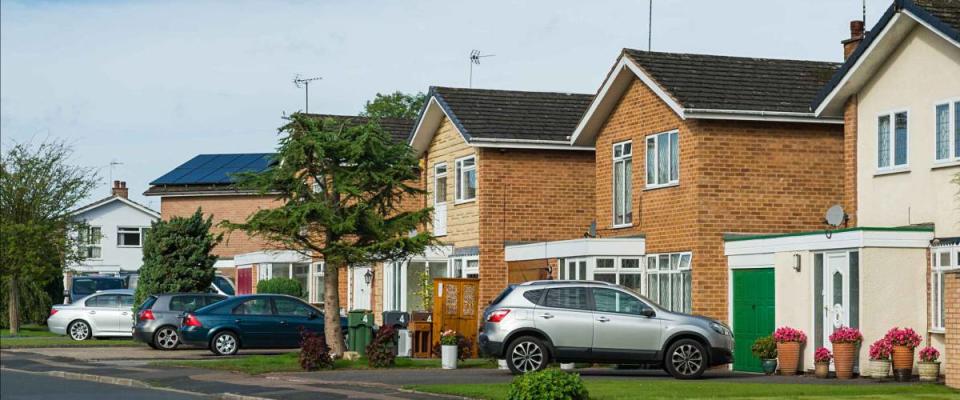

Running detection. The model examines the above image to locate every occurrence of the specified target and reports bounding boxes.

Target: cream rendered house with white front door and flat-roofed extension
[726,0,960,371]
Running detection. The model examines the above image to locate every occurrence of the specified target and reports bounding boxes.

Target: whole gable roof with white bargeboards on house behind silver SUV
[572,49,842,144]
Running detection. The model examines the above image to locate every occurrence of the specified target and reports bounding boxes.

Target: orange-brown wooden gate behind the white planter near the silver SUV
[433,278,480,357]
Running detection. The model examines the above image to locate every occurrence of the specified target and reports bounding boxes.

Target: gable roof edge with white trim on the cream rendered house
[812,0,960,116]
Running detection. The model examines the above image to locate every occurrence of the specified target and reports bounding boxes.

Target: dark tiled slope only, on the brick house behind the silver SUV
[623,49,840,113]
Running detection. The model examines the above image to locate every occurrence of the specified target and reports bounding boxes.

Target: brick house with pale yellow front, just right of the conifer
[383,87,594,311]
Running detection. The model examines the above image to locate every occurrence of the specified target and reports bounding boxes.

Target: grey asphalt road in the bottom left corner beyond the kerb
[0,370,202,400]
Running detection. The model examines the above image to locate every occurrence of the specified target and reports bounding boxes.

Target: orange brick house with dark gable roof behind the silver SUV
[506,49,843,370]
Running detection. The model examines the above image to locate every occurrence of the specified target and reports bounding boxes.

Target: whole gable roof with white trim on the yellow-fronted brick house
[408,86,593,154]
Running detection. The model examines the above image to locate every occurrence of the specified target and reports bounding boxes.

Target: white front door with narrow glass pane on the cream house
[823,252,850,350]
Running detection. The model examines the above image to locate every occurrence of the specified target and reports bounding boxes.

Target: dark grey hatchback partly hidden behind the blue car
[133,293,227,350]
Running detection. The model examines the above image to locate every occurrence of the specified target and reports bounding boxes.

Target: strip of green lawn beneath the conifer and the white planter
[153,352,497,375]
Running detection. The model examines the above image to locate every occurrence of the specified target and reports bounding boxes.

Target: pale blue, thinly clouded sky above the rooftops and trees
[0,0,892,209]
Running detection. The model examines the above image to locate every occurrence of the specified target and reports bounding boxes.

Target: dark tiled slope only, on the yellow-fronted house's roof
[430,87,593,141]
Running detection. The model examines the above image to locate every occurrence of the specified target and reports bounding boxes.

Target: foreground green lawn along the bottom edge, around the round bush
[405,378,960,400]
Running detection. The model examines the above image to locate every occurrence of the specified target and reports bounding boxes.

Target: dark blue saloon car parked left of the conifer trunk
[180,294,347,356]
